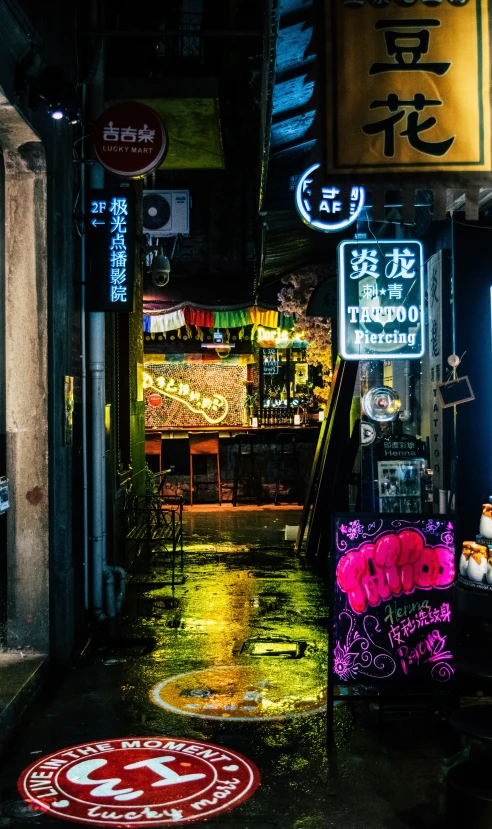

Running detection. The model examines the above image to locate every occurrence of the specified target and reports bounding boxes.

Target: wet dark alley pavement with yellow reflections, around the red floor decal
[0,508,456,829]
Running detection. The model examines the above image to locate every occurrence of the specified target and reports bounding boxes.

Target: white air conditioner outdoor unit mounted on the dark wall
[143,190,190,238]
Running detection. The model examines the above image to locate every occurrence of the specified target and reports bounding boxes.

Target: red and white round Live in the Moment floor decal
[18,737,260,827]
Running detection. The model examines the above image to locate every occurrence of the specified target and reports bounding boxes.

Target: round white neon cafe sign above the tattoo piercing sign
[295,164,365,233]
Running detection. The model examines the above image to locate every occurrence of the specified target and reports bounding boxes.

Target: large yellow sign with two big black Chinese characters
[326,0,491,173]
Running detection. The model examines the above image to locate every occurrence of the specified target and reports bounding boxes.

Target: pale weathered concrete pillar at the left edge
[0,115,49,651]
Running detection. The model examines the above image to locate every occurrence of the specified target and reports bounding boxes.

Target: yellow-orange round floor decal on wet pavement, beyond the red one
[150,662,326,721]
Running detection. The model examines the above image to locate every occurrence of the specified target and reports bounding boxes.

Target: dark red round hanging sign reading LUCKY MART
[92,101,168,178]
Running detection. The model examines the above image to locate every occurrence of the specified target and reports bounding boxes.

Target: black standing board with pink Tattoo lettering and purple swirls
[329,513,455,691]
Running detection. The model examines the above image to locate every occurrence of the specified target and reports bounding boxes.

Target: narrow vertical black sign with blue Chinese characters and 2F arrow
[86,188,135,312]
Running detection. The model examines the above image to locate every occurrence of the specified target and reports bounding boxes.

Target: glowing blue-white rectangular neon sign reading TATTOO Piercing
[338,240,424,360]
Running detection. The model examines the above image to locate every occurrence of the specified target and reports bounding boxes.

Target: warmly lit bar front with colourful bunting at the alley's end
[142,303,321,502]
